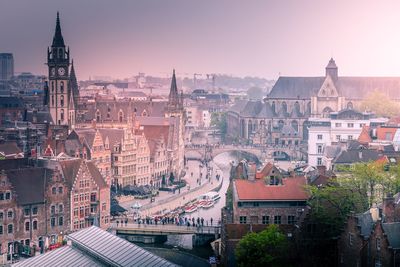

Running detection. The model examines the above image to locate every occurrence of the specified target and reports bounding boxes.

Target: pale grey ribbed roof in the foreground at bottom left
[68,226,176,267]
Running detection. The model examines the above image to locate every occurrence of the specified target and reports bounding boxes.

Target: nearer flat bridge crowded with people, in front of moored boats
[110,223,221,235]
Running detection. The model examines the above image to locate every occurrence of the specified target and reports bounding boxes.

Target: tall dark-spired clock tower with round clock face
[47,12,75,129]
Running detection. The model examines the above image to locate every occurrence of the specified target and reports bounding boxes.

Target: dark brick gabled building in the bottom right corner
[338,195,400,266]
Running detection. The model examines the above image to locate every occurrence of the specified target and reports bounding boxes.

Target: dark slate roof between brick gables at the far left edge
[6,168,51,205]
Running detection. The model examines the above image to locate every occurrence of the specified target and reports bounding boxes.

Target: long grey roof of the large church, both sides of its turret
[268,77,400,99]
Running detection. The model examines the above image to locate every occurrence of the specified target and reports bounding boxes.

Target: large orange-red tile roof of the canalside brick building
[234,176,308,201]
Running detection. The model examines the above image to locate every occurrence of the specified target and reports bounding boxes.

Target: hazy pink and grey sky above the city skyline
[0,0,400,79]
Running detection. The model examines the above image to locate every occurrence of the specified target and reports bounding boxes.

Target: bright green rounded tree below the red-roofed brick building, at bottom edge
[235,224,288,267]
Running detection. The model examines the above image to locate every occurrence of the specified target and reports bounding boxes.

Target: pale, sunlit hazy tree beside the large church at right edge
[360,90,400,117]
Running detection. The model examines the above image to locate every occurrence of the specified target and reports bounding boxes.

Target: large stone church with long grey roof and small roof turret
[227,58,400,148]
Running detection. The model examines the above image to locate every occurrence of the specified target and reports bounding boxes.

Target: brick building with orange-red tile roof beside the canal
[221,161,308,266]
